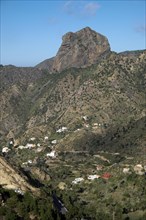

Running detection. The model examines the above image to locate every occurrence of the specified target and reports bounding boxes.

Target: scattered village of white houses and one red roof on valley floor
[1,120,146,193]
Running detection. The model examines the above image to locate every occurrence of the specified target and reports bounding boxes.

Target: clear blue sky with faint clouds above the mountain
[0,0,146,66]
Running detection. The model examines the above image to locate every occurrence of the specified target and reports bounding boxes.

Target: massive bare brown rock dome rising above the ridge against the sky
[36,27,110,72]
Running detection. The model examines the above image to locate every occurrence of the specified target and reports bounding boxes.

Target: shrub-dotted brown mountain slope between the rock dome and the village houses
[1,51,146,147]
